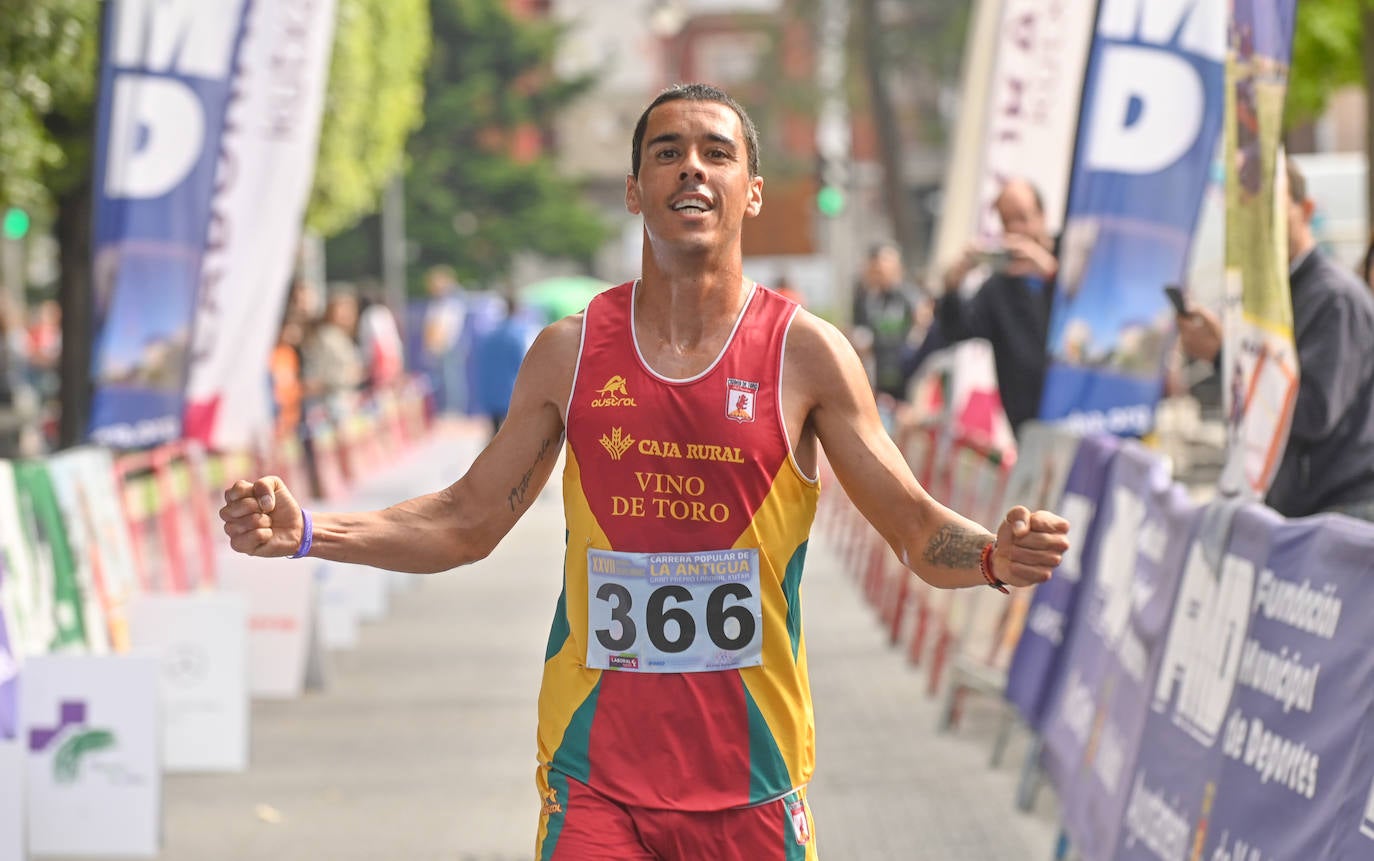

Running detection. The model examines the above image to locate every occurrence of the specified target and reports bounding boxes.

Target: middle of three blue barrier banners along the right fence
[1043,444,1198,860]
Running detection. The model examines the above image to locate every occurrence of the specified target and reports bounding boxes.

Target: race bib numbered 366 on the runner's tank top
[587,549,764,673]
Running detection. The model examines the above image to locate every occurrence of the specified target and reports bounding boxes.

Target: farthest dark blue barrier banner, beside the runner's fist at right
[1006,434,1120,732]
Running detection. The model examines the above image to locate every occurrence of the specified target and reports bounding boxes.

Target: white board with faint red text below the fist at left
[217,551,315,699]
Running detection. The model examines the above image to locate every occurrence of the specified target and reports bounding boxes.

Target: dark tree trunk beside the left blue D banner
[56,181,95,448]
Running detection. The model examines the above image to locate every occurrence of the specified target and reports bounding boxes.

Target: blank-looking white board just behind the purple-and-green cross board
[129,593,249,773]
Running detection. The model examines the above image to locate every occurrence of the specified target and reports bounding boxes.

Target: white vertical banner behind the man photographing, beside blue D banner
[972,0,1098,245]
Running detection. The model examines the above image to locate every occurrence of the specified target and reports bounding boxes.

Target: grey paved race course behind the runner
[80,425,1055,861]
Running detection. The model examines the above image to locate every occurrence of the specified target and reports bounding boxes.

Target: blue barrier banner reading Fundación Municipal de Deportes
[1114,505,1374,861]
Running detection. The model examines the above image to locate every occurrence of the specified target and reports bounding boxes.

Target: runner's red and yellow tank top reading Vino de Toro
[539,283,819,810]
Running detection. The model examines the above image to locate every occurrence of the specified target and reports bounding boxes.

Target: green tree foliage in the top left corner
[0,0,100,209]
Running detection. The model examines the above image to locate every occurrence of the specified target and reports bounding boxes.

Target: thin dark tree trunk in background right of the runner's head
[855,0,921,266]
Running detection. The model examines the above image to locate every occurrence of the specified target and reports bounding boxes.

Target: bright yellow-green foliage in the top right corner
[1285,0,1374,126]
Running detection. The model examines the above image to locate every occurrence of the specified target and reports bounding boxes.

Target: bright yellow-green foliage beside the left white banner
[306,0,430,236]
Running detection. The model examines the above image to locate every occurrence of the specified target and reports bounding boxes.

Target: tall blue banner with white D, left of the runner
[89,0,250,448]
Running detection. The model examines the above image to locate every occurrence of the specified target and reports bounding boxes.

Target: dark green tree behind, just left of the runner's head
[405,0,620,284]
